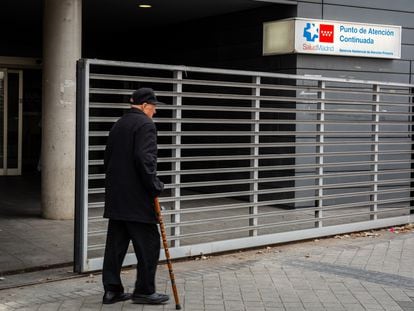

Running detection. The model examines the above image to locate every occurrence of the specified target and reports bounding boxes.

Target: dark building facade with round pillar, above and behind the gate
[0,0,414,219]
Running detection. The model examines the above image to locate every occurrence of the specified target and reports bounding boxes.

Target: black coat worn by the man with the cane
[104,108,164,223]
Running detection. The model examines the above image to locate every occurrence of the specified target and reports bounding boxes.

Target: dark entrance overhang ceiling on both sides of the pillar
[0,0,297,27]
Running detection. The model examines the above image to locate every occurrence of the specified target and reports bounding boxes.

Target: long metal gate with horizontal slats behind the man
[75,59,414,272]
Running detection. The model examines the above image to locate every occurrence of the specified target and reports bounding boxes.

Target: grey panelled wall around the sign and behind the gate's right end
[296,0,414,210]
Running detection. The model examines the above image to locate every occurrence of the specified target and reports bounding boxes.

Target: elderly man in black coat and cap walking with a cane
[102,88,169,304]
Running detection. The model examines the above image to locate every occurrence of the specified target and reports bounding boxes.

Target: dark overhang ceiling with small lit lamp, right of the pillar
[83,0,297,28]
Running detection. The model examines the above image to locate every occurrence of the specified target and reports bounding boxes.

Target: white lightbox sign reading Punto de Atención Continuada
[263,18,401,59]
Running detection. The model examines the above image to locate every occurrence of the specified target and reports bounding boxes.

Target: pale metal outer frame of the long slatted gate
[74,59,414,273]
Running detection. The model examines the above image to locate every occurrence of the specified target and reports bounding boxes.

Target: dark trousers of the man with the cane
[102,219,161,295]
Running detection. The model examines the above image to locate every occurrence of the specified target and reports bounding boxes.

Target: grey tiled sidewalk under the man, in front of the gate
[0,230,414,311]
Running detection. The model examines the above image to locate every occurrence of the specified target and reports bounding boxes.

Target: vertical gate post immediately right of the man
[171,71,183,247]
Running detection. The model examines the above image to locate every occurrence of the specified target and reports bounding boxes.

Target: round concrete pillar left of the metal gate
[42,0,82,219]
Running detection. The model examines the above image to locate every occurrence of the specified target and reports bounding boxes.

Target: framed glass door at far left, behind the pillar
[0,69,23,175]
